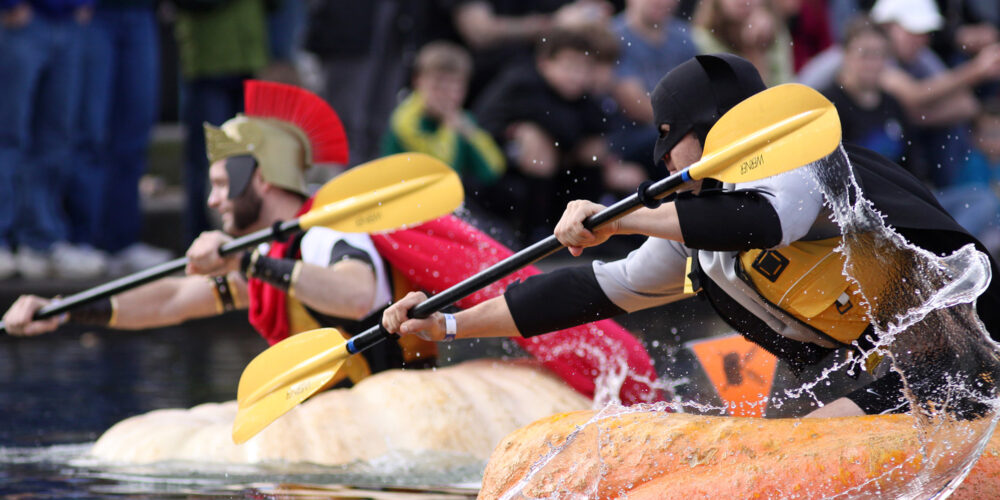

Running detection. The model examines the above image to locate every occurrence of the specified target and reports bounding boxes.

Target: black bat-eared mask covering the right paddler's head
[650,54,767,162]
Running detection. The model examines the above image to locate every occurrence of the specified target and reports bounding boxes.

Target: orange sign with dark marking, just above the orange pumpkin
[690,335,778,417]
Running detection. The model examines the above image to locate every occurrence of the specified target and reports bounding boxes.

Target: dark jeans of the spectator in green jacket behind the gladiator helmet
[181,75,250,243]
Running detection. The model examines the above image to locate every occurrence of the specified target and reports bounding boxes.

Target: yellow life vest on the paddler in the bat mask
[739,237,869,344]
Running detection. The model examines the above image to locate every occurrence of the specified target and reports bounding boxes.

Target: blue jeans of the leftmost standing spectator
[0,17,83,251]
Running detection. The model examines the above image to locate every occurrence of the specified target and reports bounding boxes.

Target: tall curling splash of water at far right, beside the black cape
[811,149,1000,498]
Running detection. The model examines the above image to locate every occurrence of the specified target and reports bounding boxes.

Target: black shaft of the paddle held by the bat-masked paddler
[347,169,691,354]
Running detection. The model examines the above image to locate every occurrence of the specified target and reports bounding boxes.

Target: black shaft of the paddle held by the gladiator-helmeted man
[0,219,299,332]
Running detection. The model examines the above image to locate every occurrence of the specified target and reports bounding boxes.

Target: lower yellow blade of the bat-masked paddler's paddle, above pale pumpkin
[233,328,350,443]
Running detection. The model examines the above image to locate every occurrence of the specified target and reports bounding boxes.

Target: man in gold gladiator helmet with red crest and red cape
[4,81,660,404]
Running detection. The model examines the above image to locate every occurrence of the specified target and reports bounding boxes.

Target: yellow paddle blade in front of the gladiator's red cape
[299,153,464,233]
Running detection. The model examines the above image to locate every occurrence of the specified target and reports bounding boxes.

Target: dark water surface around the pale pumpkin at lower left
[0,314,483,499]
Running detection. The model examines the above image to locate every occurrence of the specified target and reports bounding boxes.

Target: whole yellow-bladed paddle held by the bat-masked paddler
[233,84,840,443]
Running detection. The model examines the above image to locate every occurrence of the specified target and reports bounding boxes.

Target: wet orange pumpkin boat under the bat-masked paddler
[479,411,1000,500]
